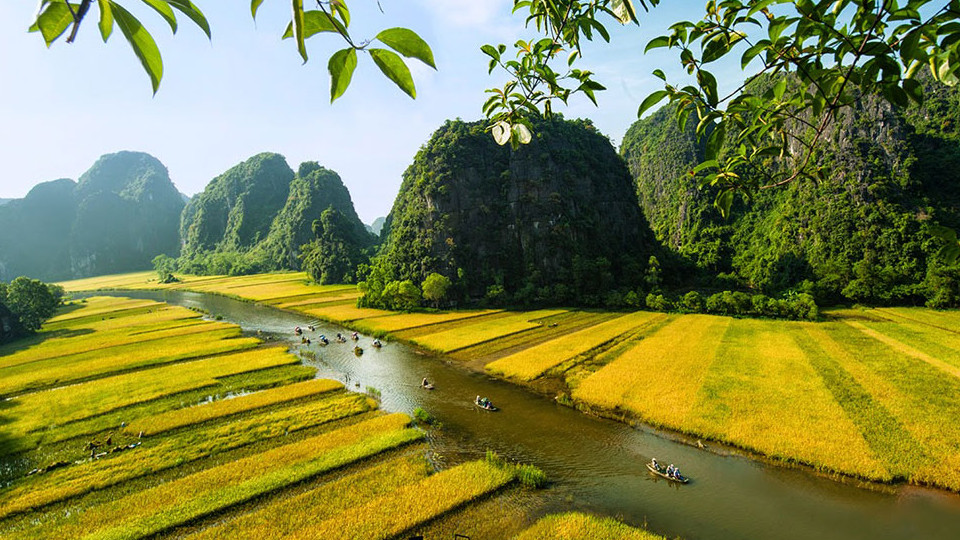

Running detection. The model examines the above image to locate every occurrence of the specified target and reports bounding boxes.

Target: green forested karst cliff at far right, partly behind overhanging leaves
[621,77,960,303]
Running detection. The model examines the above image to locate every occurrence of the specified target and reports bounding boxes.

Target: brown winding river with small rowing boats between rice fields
[101,291,960,540]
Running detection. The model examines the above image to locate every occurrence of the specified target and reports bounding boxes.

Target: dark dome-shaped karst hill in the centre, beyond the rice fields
[378,119,654,302]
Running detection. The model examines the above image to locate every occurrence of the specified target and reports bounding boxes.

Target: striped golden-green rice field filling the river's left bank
[0,298,576,539]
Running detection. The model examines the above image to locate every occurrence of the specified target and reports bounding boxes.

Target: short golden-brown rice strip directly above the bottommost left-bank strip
[187,455,432,540]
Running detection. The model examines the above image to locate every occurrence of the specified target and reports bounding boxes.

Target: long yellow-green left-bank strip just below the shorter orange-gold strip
[0,394,373,518]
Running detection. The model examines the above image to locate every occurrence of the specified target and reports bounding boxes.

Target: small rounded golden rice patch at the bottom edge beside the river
[513,513,664,540]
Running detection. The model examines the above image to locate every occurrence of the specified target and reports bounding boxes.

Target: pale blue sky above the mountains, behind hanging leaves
[0,0,728,223]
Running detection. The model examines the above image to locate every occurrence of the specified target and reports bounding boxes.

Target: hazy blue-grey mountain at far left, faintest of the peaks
[0,152,183,281]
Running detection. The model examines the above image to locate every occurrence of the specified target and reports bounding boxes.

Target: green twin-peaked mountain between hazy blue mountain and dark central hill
[179,153,375,281]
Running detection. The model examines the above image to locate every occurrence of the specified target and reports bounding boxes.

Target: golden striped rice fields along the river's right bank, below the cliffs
[56,273,960,491]
